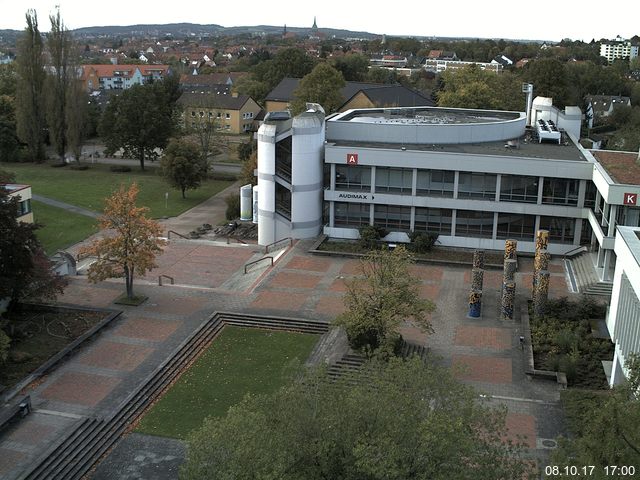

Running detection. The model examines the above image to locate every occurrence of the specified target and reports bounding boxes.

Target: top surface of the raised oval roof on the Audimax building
[330,107,520,125]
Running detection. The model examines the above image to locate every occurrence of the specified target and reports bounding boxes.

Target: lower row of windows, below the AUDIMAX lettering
[333,202,575,244]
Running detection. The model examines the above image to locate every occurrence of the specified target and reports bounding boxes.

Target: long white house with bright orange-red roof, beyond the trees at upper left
[81,65,171,92]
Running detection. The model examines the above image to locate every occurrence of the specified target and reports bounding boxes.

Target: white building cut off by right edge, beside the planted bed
[607,227,640,386]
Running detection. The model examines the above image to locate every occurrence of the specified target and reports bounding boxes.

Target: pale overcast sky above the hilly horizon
[0,0,640,42]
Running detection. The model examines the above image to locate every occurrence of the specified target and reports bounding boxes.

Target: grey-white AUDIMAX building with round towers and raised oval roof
[258,98,640,281]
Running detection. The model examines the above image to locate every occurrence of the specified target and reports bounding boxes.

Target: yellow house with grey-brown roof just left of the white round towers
[178,89,261,134]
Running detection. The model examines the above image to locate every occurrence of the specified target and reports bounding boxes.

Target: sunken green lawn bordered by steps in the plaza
[137,327,318,439]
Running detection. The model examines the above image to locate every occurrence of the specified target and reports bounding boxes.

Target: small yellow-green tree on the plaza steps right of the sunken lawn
[334,246,435,355]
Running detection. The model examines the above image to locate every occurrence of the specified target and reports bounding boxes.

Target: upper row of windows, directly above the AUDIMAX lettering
[335,165,584,206]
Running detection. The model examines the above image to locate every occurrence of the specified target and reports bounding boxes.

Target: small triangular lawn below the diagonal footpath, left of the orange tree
[31,200,98,255]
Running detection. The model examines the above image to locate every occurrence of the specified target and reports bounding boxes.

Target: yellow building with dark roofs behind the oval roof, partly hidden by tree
[265,77,434,112]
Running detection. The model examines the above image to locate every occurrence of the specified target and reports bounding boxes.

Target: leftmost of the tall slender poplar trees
[16,10,46,162]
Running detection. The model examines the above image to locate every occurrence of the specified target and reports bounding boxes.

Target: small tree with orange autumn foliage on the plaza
[80,183,165,299]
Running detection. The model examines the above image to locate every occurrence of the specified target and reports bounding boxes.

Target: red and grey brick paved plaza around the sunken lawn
[0,236,568,479]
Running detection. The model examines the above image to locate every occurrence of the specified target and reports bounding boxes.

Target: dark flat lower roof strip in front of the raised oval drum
[328,138,587,162]
